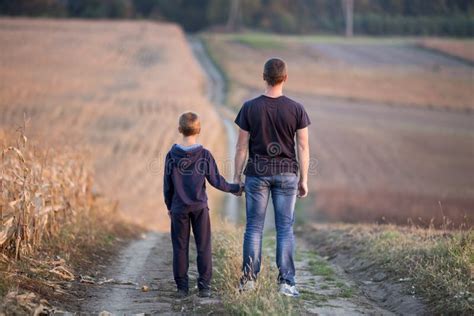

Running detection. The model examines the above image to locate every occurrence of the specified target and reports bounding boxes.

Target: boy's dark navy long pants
[171,208,212,291]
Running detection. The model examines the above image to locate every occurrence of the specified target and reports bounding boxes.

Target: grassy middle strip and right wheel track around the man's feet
[213,223,368,315]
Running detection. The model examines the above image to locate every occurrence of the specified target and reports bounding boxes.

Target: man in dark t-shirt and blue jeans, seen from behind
[234,58,311,297]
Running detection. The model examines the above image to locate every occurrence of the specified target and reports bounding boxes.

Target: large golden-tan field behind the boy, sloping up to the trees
[0,19,229,229]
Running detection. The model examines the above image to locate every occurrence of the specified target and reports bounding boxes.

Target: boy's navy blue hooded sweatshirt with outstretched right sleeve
[163,144,240,213]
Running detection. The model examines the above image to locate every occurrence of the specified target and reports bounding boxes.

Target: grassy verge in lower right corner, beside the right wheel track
[307,224,474,315]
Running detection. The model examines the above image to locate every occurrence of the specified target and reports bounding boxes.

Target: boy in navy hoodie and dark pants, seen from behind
[163,112,242,298]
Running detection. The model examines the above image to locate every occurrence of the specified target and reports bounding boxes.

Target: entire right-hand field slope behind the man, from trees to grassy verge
[204,34,474,226]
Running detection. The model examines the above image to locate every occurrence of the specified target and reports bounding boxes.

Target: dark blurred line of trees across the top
[0,0,474,37]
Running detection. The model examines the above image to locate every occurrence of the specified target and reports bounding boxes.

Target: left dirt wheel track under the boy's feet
[81,232,220,315]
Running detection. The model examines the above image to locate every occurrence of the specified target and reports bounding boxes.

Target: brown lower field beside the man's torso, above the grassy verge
[304,96,474,225]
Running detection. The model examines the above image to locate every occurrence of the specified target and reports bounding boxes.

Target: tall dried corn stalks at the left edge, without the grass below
[0,128,94,259]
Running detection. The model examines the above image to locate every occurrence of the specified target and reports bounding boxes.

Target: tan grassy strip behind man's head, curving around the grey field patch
[203,34,474,109]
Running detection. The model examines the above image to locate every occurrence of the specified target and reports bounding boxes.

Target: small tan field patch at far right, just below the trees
[418,38,474,63]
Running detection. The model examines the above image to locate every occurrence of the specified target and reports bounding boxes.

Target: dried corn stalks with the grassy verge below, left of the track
[0,128,139,314]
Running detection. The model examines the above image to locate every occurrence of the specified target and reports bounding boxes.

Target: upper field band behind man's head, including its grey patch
[206,34,474,109]
